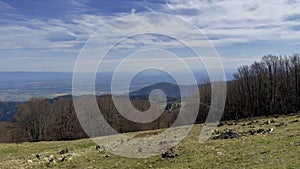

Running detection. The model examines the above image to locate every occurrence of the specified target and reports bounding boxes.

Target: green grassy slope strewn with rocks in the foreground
[0,116,300,168]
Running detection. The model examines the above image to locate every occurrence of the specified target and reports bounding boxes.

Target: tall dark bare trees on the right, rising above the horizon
[198,54,300,122]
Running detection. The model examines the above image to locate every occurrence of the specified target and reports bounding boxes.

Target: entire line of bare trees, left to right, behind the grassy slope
[4,54,300,142]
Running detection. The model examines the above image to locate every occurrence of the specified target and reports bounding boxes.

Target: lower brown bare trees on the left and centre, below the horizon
[10,95,179,142]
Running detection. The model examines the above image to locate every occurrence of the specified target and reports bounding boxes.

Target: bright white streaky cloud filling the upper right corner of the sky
[165,0,300,46]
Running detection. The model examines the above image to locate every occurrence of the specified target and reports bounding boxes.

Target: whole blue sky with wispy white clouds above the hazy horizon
[0,0,300,72]
